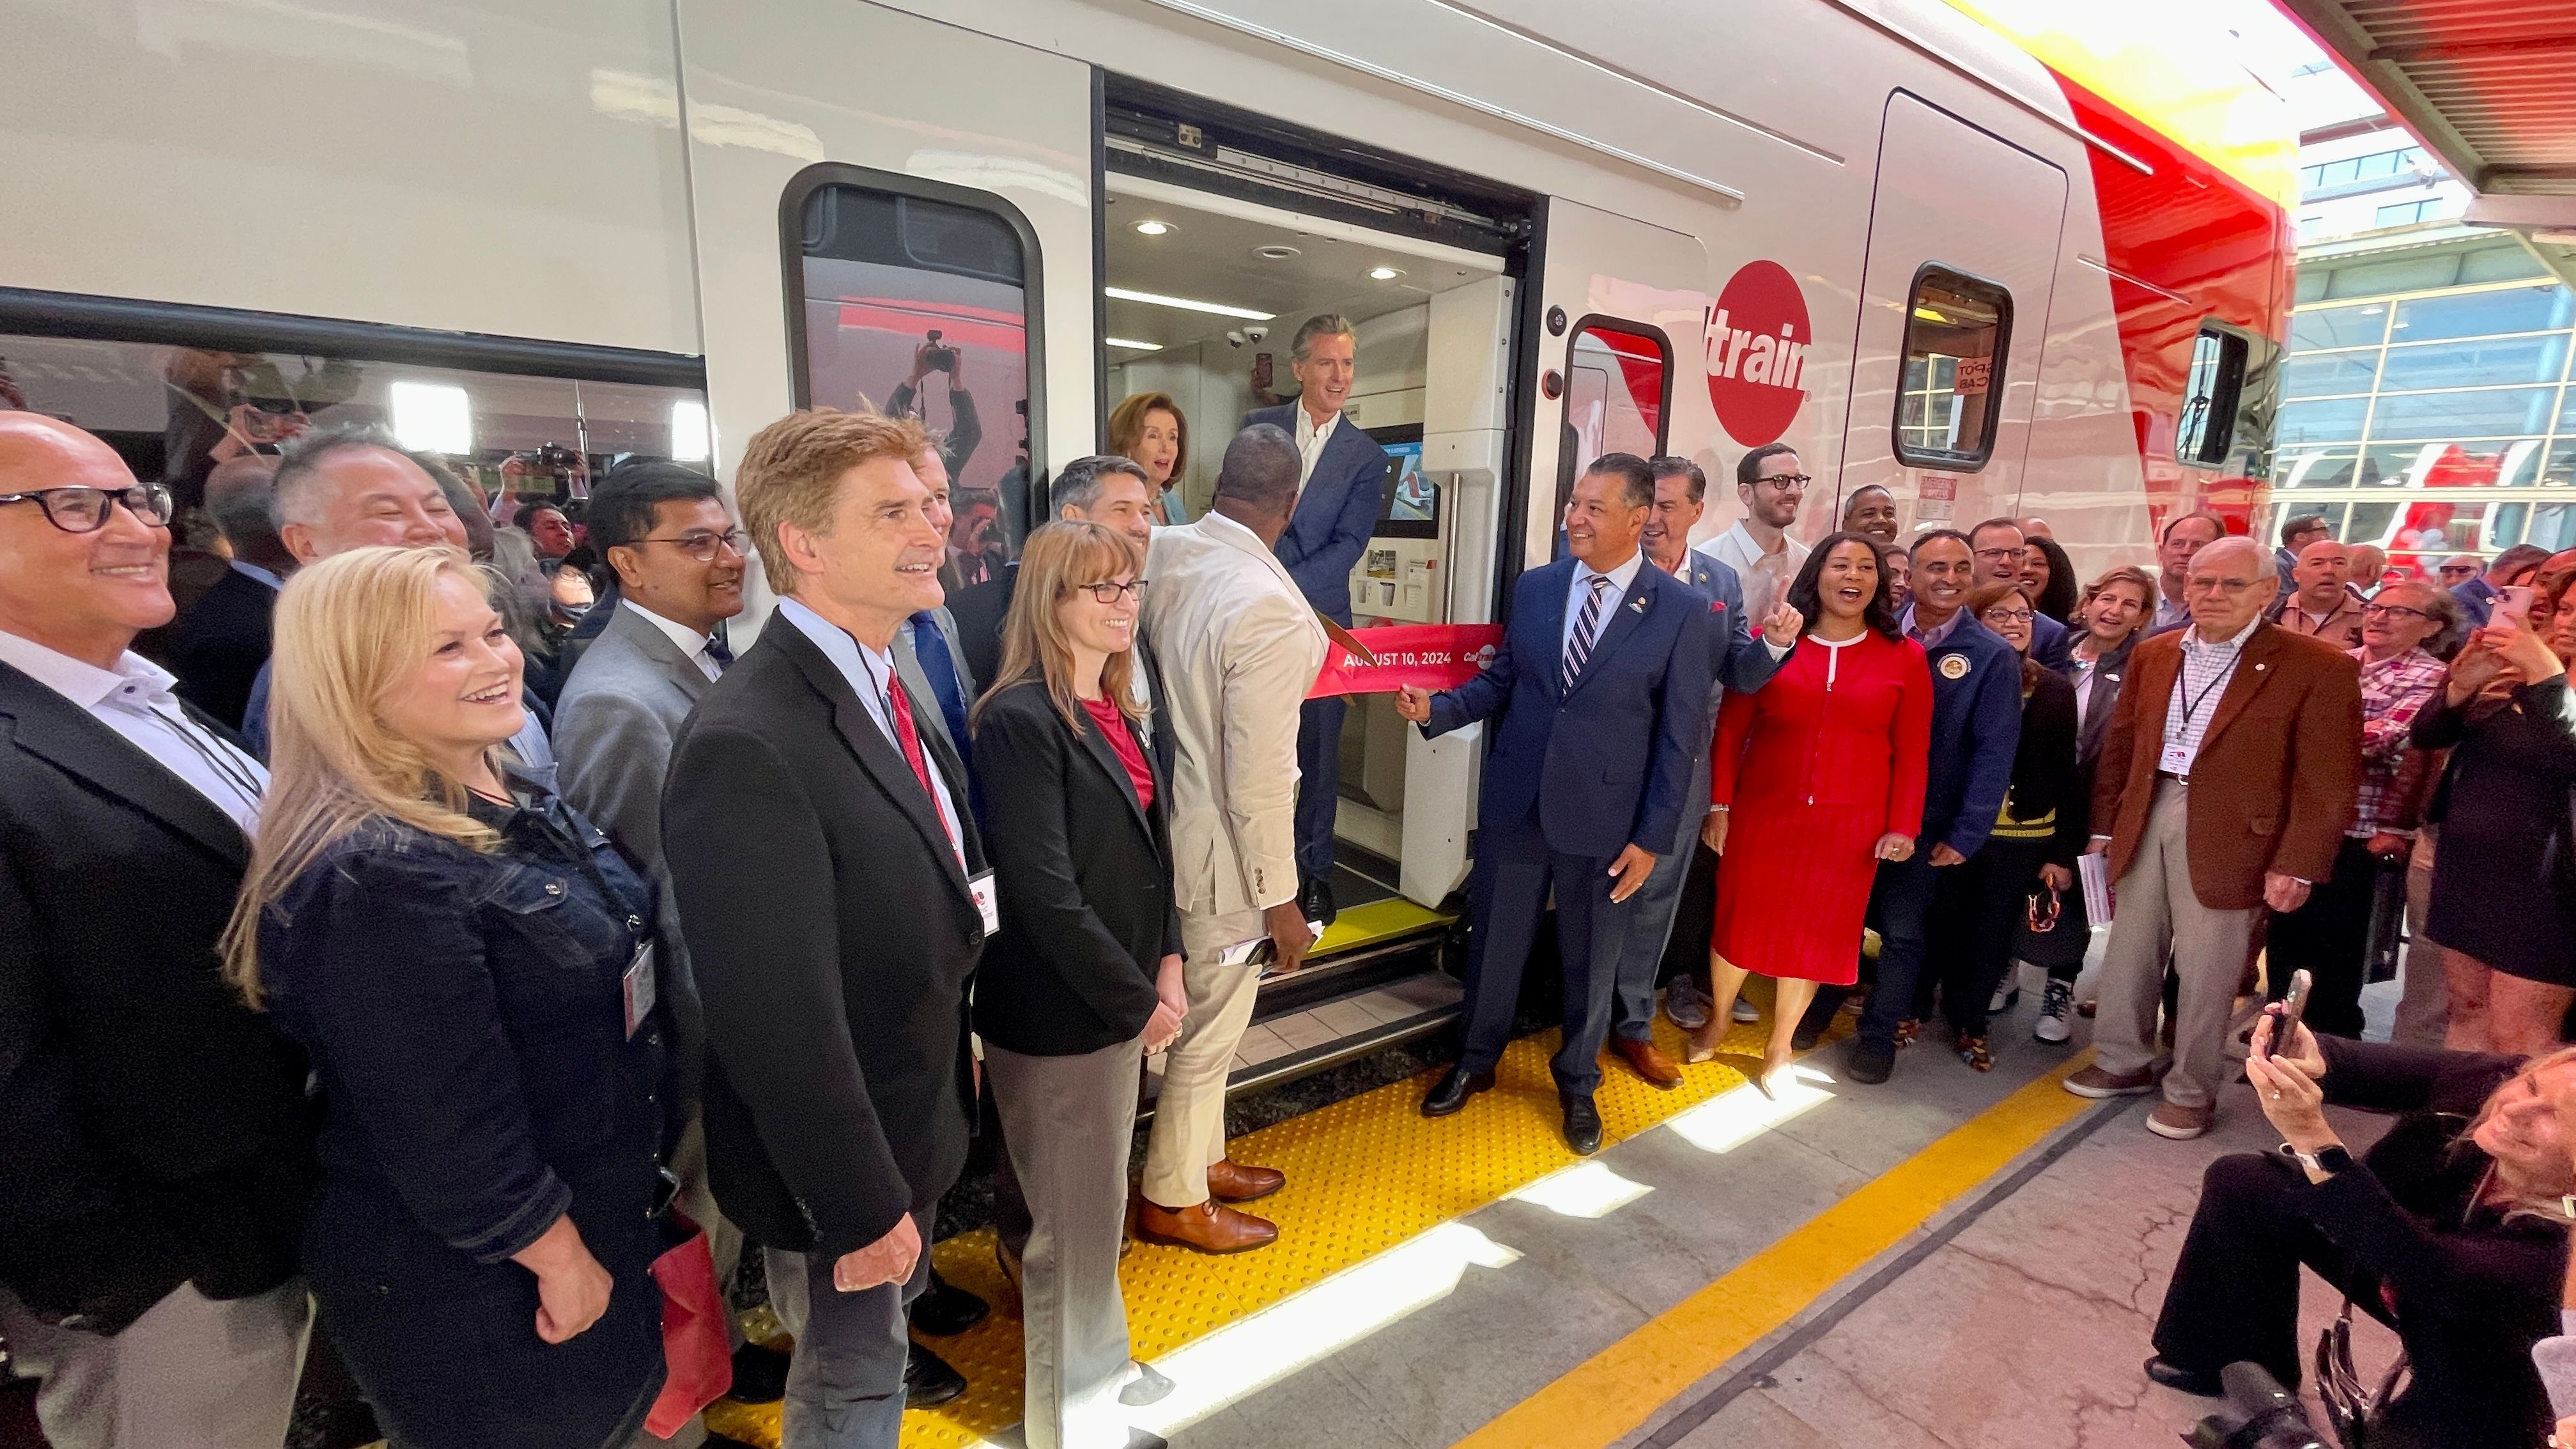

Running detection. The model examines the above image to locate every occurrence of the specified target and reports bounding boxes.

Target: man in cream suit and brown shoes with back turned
[1136,423,1329,1253]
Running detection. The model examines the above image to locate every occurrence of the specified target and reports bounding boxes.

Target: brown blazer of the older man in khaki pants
[2094,624,2362,910]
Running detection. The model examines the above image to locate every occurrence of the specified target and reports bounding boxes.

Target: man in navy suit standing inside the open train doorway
[1242,312,1386,926]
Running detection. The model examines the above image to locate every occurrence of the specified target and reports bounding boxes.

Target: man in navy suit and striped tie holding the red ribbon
[1396,454,1713,1155]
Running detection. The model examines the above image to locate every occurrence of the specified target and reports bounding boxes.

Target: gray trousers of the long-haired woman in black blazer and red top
[984,1037,1144,1449]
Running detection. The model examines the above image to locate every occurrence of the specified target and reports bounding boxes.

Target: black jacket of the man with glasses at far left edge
[0,665,312,1333]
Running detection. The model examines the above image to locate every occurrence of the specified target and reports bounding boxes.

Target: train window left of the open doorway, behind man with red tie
[785,165,1046,562]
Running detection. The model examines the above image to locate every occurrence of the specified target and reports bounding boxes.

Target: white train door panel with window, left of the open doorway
[670,0,1095,616]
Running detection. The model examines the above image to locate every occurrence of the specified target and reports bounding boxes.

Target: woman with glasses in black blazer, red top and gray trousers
[971,513,1187,1449]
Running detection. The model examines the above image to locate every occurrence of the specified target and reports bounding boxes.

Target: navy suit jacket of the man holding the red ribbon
[1422,559,1720,858]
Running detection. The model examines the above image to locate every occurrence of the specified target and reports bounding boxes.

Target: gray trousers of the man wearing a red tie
[762,1214,930,1449]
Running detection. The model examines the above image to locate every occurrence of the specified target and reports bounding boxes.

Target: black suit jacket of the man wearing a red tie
[662,616,984,1258]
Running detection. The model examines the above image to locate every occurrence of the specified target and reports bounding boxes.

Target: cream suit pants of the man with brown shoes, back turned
[1144,910,1262,1207]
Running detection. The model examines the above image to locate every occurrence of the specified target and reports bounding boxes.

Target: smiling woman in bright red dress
[1687,534,1932,1096]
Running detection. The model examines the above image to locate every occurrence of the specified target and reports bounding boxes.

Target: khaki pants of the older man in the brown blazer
[2094,779,2256,1106]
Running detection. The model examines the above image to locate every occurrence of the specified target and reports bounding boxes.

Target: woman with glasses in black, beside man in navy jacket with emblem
[1914,583,2084,1073]
